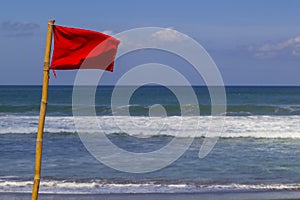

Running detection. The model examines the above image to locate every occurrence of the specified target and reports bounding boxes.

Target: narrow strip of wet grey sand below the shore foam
[0,190,300,200]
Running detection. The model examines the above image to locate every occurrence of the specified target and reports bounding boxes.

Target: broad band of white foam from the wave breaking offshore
[0,115,300,138]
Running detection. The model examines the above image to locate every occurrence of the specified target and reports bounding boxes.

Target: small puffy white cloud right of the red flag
[152,28,188,42]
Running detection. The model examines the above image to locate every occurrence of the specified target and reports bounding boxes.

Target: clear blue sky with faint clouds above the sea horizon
[0,0,300,85]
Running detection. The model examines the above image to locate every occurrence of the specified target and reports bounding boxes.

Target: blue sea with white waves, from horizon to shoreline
[0,86,300,193]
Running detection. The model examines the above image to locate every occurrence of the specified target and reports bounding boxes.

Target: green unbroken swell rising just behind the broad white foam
[0,103,300,116]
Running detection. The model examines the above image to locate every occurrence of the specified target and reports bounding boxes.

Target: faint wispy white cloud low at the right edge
[255,36,300,58]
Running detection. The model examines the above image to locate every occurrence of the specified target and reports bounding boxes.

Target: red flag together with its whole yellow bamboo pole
[32,20,120,200]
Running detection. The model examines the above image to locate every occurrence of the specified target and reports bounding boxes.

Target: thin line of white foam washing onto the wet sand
[0,181,300,194]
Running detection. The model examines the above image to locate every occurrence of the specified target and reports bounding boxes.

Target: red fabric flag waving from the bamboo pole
[50,25,120,71]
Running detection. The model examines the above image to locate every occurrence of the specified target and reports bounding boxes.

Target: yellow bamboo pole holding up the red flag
[32,20,55,200]
